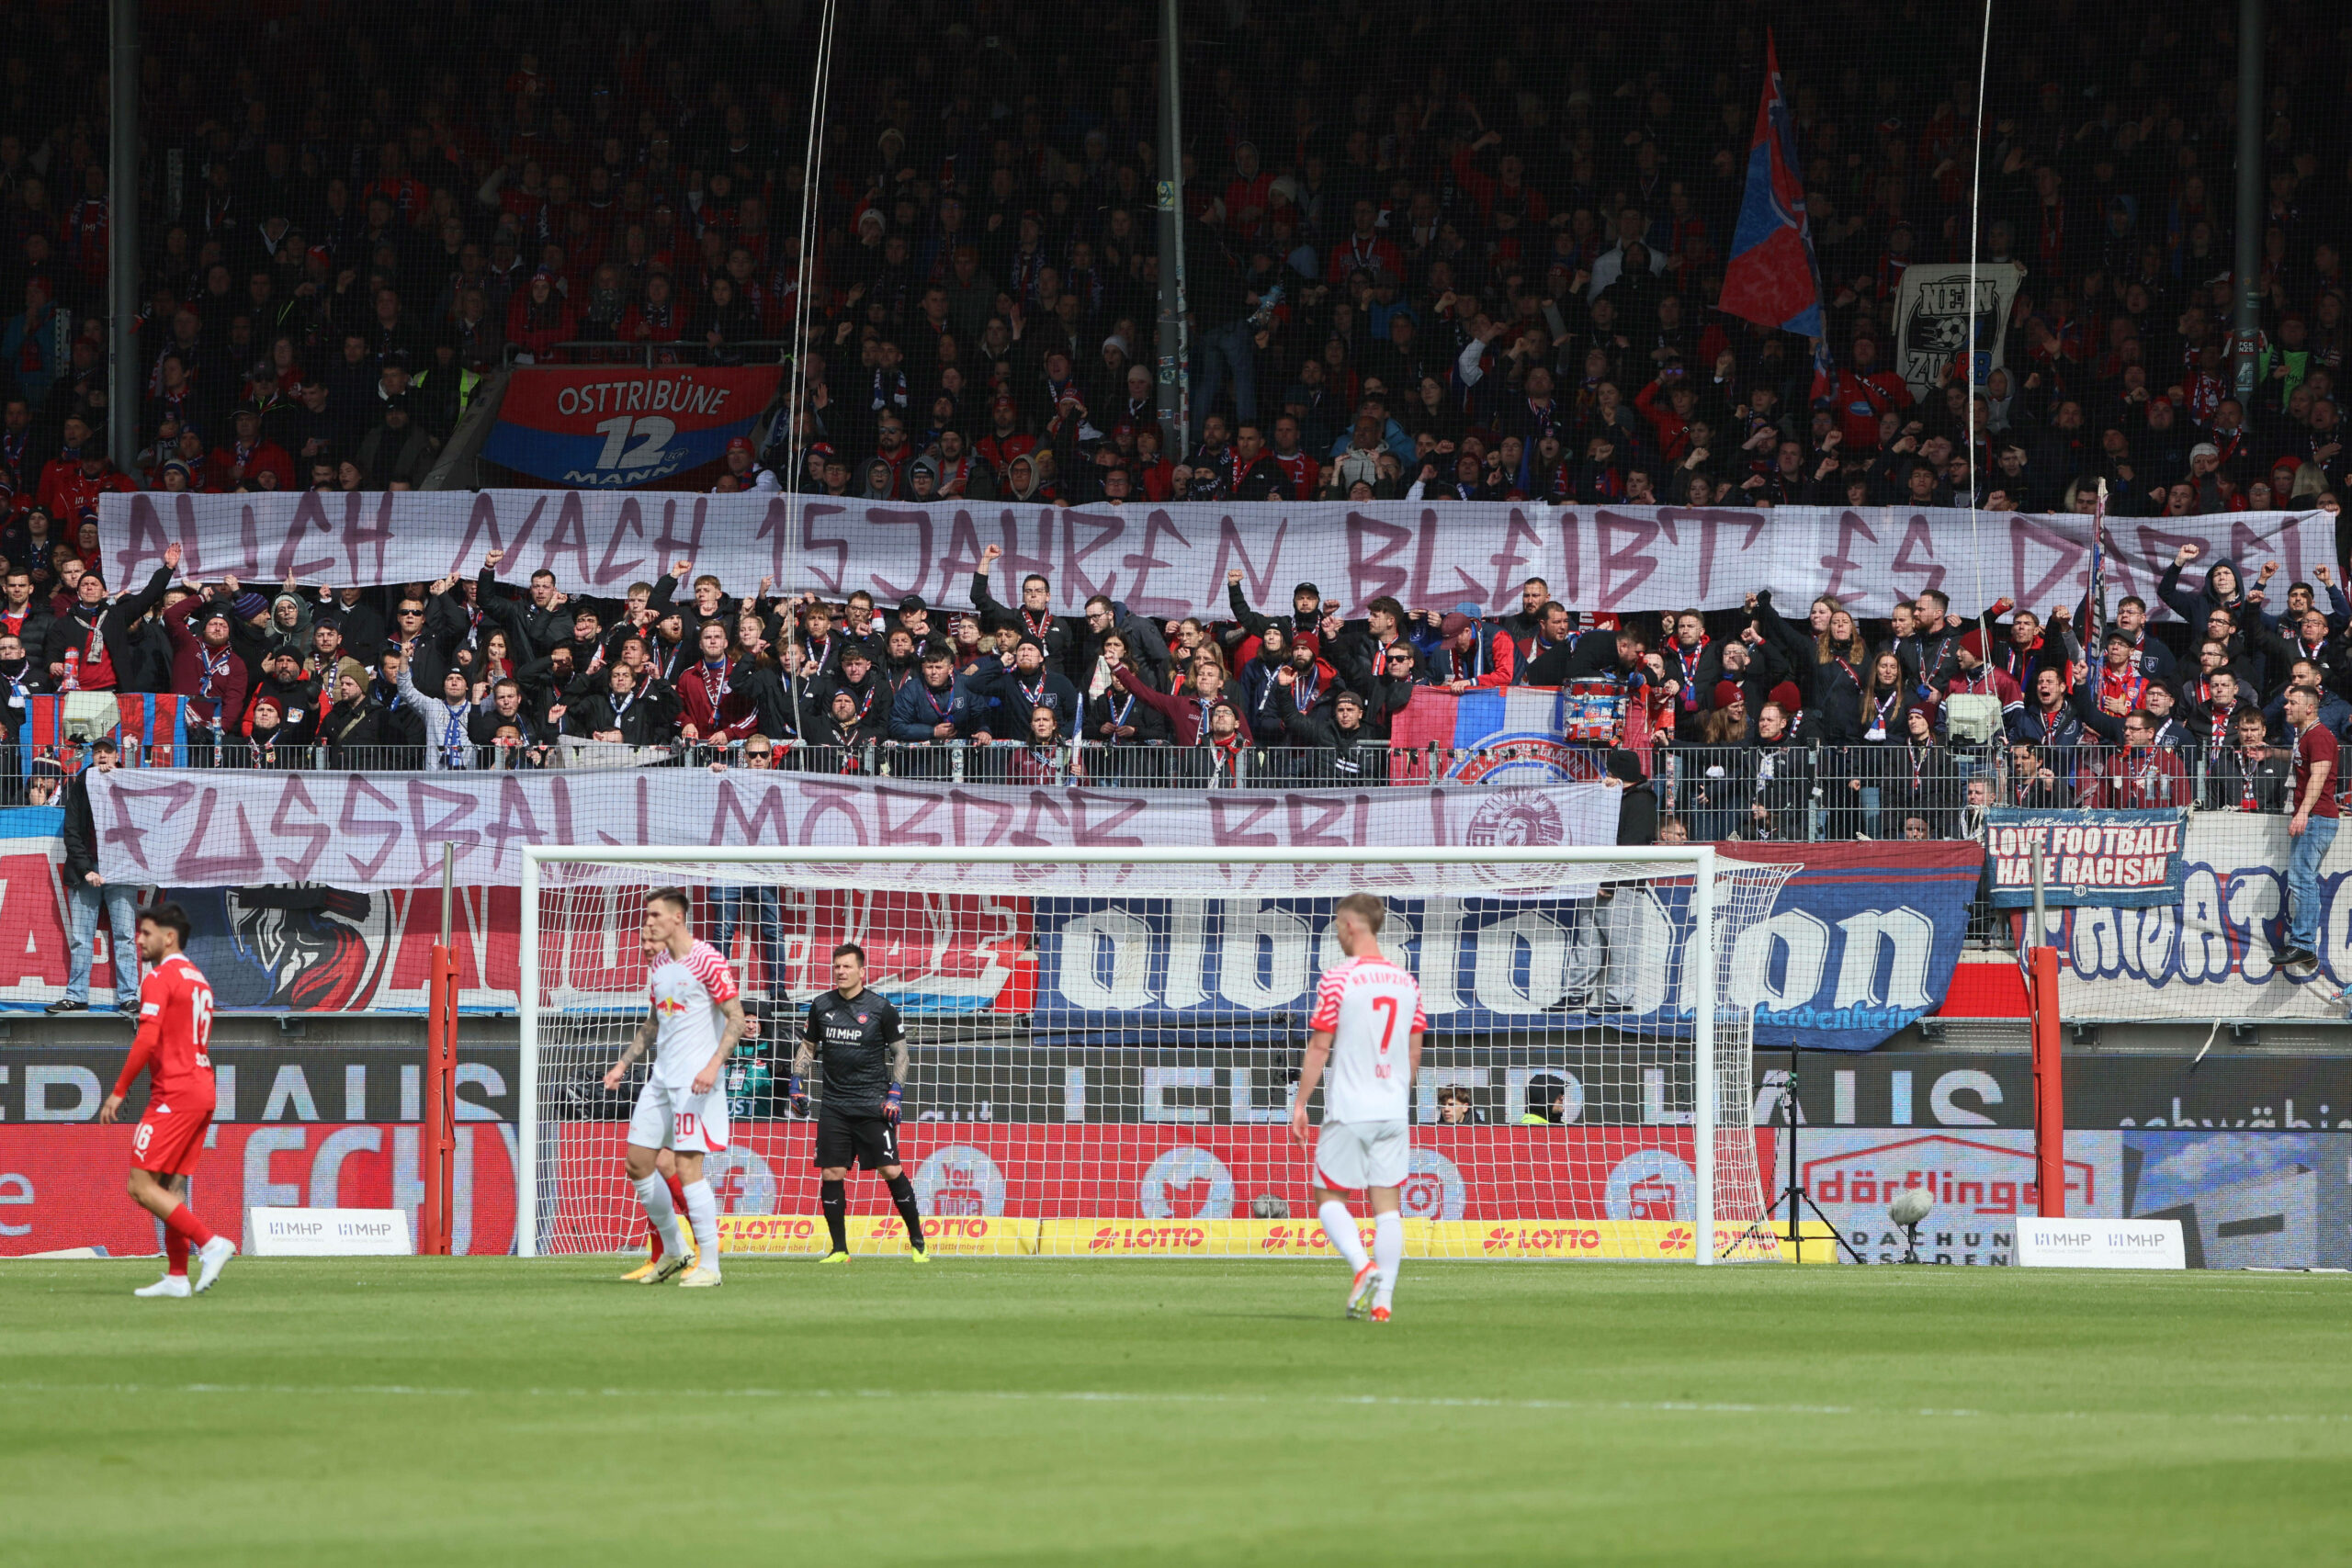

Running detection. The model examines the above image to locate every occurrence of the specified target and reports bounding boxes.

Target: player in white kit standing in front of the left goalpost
[605,888,743,1286]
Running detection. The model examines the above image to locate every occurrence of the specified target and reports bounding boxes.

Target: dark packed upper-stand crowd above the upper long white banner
[0,0,2352,522]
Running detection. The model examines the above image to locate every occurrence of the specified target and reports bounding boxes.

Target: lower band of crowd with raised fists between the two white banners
[0,533,2352,840]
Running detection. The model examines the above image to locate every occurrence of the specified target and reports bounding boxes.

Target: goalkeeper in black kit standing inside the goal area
[793,942,932,1262]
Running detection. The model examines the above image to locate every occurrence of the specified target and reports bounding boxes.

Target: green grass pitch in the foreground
[0,1258,2352,1568]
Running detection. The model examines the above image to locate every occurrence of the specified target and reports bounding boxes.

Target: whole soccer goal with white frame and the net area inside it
[517,844,1792,1262]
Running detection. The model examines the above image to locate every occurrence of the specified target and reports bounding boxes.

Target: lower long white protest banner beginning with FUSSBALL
[89,769,1618,896]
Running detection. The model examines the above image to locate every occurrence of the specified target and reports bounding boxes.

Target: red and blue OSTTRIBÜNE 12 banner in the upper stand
[482,365,783,489]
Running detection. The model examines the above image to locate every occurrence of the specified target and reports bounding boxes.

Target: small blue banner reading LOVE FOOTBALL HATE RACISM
[1985,807,2189,909]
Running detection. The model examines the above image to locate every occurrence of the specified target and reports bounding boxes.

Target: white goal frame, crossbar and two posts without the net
[515,844,1749,1265]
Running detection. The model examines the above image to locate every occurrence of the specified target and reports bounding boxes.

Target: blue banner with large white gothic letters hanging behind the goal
[1030,844,1981,1051]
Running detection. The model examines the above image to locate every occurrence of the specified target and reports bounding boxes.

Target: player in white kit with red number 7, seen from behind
[1291,894,1430,1324]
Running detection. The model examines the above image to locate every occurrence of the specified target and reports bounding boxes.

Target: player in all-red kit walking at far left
[99,903,238,1298]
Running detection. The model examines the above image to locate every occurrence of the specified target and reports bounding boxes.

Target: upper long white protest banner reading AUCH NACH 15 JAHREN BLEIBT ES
[99,489,2335,618]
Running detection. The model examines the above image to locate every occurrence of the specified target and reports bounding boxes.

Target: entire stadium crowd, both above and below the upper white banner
[0,0,2352,837]
